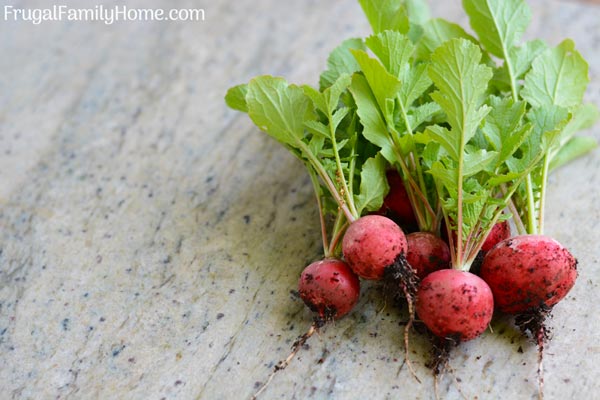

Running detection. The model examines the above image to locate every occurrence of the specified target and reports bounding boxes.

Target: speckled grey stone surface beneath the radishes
[0,0,600,399]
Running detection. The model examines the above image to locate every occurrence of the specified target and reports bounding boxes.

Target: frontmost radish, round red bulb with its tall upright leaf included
[409,39,503,343]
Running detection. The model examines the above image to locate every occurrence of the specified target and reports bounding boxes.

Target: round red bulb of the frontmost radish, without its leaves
[416,269,494,342]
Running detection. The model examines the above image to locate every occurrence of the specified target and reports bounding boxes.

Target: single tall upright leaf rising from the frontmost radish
[425,39,498,269]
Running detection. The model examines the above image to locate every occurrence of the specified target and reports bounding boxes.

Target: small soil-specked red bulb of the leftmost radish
[298,258,360,320]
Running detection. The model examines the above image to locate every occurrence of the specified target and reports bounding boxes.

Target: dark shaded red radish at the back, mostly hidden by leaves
[379,170,417,227]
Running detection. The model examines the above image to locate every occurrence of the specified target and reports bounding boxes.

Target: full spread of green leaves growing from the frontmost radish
[425,39,566,269]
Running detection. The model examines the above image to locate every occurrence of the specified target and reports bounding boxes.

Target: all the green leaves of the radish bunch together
[226,0,598,269]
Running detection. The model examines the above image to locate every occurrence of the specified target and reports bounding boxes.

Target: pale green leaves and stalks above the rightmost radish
[463,0,598,233]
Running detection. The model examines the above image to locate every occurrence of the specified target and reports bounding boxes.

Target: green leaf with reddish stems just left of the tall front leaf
[350,31,440,232]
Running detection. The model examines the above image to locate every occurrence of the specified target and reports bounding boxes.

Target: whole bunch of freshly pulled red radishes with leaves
[226,0,598,396]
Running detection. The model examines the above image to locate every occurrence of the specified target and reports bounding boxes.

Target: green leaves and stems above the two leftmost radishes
[225,73,389,257]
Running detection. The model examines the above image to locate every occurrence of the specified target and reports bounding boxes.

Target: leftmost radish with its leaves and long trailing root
[226,73,394,397]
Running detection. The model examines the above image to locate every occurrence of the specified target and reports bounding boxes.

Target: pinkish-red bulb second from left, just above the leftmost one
[342,215,407,280]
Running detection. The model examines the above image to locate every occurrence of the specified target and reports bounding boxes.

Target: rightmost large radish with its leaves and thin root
[472,7,597,390]
